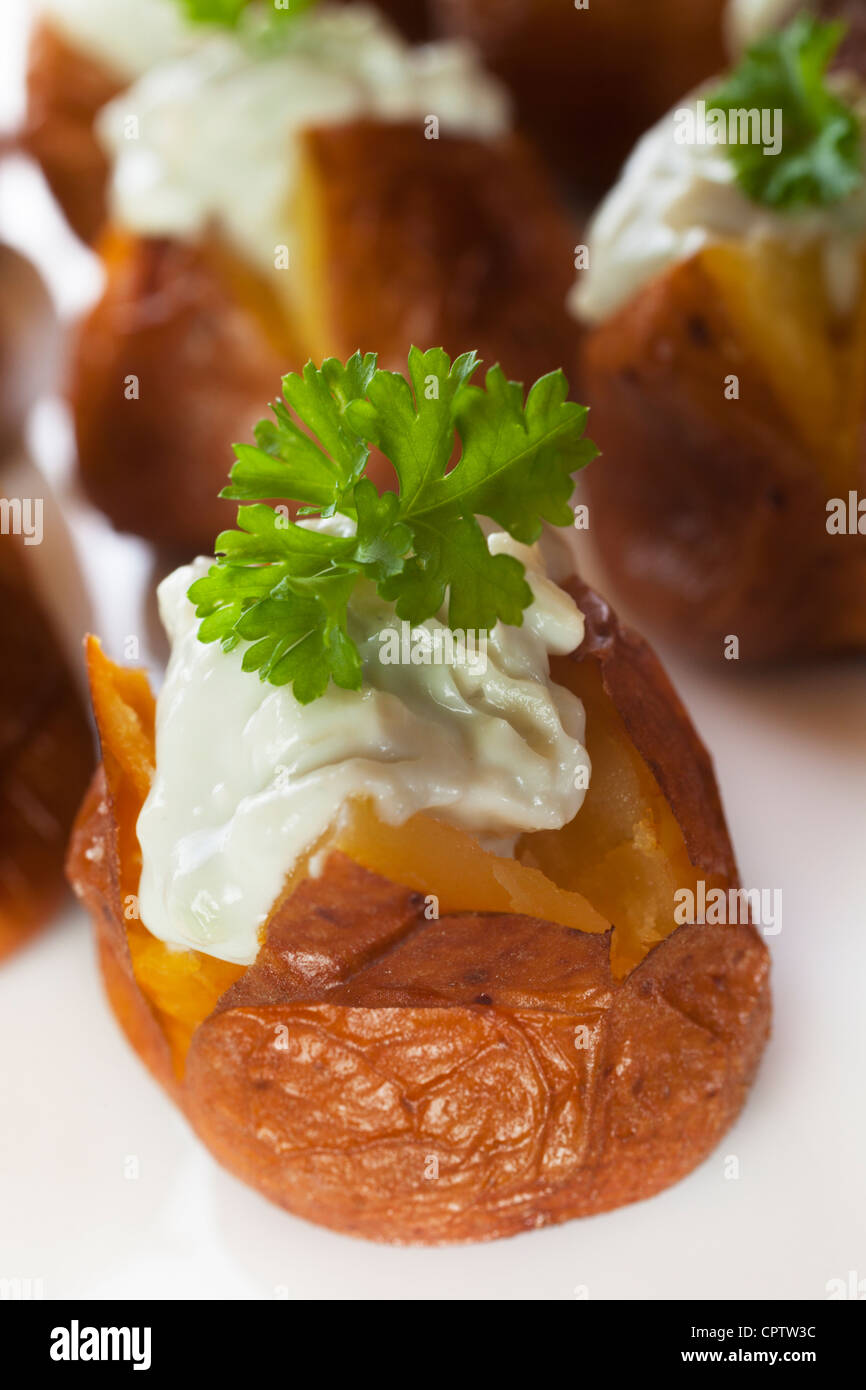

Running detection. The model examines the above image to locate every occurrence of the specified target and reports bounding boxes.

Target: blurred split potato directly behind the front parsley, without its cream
[71,122,577,552]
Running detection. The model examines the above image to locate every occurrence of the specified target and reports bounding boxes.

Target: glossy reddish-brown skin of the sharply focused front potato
[70,585,770,1244]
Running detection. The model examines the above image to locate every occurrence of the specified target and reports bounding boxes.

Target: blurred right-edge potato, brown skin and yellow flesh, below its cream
[581,242,866,662]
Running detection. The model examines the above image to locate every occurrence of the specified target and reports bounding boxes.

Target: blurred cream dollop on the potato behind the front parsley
[99,6,510,271]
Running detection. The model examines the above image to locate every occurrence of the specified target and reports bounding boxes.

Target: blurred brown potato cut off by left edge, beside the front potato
[0,537,95,959]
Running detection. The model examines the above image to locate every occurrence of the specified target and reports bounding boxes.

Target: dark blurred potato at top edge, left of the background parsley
[431,0,724,190]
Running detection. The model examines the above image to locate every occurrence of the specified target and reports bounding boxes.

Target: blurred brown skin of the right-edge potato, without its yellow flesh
[581,259,866,663]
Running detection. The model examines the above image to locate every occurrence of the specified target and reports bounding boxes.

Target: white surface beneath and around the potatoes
[0,0,866,1300]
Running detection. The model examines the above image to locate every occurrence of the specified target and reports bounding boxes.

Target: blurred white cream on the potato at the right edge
[569,76,866,324]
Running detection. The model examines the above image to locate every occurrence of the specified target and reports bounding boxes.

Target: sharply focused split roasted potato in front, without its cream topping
[70,581,770,1244]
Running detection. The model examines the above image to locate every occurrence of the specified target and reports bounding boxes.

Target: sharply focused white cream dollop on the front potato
[138,534,589,965]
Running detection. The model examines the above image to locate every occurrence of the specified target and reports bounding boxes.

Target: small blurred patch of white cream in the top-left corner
[39,0,189,81]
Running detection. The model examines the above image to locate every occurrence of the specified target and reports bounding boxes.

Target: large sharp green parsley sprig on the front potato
[189,348,598,705]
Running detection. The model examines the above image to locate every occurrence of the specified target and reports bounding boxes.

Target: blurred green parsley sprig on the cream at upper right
[706,14,862,211]
